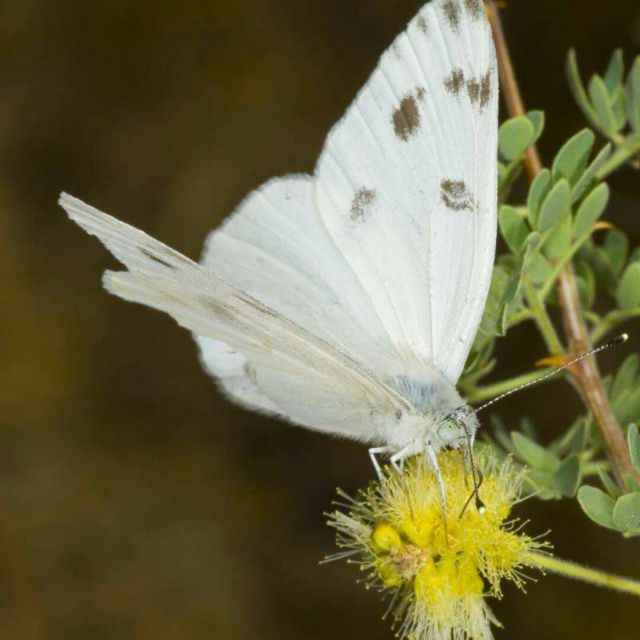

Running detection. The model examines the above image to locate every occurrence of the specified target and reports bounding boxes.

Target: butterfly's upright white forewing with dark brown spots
[315,0,498,383]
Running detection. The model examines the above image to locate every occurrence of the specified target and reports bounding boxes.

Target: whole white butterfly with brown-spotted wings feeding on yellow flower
[60,0,498,480]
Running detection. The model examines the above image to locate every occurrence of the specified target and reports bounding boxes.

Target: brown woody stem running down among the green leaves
[487,0,640,488]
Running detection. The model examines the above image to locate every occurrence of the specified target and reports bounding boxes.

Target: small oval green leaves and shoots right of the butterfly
[460,46,640,537]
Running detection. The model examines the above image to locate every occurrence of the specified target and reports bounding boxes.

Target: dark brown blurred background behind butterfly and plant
[0,0,640,640]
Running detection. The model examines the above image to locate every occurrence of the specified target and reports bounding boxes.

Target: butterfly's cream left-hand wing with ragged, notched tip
[60,194,406,441]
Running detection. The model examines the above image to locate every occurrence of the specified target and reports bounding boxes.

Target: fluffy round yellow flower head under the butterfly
[329,450,546,640]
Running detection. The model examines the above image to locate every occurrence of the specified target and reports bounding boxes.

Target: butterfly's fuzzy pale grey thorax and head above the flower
[383,369,478,455]
